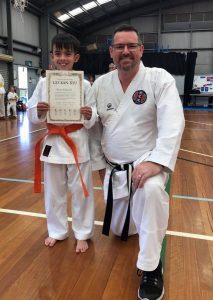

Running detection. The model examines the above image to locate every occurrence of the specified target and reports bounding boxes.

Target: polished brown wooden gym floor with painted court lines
[0,111,213,300]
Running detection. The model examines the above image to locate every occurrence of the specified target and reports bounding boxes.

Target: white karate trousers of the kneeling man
[104,172,169,271]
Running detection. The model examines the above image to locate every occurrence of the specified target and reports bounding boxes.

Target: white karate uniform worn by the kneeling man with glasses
[88,63,184,271]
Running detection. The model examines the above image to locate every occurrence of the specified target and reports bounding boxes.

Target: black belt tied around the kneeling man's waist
[102,160,133,241]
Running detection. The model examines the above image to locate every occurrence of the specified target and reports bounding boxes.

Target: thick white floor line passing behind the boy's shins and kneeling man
[0,208,213,241]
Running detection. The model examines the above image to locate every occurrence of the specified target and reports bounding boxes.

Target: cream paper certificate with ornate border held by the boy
[46,70,84,124]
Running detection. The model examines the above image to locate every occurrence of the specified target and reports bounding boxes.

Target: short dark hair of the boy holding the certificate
[52,33,80,54]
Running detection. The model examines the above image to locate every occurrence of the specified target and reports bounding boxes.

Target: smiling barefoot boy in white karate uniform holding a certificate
[28,34,96,253]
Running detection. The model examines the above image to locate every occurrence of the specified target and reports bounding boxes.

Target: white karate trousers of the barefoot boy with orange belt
[44,161,94,240]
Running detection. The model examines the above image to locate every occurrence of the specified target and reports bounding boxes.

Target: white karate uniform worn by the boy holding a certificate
[27,78,97,240]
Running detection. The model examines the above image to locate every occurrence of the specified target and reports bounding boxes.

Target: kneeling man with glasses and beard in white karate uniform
[88,25,184,300]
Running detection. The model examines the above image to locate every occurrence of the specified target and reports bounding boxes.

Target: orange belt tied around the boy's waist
[34,124,89,197]
